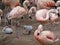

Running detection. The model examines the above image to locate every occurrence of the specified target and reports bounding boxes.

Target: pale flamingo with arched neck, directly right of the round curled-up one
[47,9,58,23]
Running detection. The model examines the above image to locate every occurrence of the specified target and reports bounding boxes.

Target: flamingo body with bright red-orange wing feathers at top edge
[28,0,55,10]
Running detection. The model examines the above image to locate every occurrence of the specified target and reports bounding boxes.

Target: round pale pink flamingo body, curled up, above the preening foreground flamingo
[35,9,49,24]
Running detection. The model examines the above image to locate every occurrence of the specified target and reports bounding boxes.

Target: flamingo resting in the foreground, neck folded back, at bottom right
[34,25,59,45]
